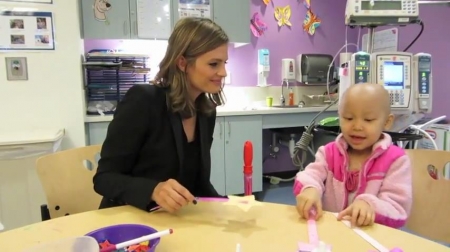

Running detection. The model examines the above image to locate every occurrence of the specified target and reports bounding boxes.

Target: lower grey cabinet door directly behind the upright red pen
[225,116,263,195]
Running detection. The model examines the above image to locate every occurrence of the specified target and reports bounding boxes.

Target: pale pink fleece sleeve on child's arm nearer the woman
[294,146,328,196]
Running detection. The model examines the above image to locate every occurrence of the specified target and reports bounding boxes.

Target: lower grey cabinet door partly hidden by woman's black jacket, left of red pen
[211,117,226,195]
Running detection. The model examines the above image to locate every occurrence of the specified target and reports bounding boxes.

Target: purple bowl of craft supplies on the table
[85,224,160,252]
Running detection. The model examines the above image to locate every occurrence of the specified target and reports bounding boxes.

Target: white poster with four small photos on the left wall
[0,11,55,50]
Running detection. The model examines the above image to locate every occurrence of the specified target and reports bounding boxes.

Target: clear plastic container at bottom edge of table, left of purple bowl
[23,236,98,252]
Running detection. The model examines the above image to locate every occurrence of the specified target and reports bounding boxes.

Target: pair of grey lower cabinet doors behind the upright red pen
[211,115,263,195]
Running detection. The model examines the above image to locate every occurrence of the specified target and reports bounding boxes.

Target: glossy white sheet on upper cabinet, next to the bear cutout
[137,0,172,39]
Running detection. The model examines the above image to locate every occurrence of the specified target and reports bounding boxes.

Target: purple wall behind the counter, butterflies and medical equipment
[85,0,450,175]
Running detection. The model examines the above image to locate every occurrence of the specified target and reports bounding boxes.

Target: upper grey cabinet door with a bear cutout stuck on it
[80,0,131,39]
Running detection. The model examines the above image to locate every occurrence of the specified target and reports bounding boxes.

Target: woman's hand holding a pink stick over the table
[152,179,195,213]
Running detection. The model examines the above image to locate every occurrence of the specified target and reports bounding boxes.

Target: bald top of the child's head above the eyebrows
[339,83,391,116]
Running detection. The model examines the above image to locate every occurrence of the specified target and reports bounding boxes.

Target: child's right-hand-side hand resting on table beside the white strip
[337,200,375,227]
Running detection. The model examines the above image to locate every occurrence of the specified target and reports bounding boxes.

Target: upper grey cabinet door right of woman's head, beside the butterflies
[212,0,251,43]
